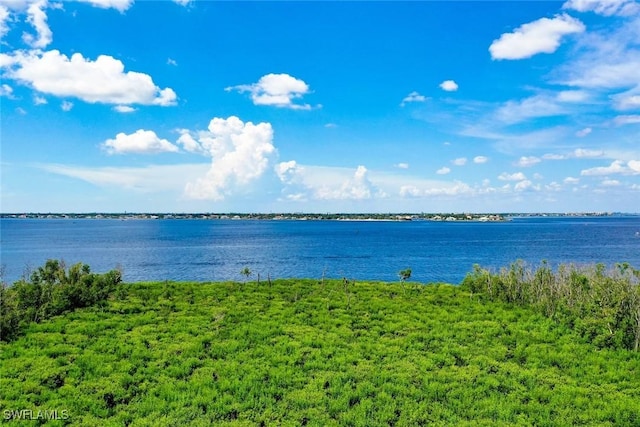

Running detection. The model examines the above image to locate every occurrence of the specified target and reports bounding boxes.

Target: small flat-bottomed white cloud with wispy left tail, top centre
[225,74,311,110]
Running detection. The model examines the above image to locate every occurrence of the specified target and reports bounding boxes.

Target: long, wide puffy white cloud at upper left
[0,50,176,106]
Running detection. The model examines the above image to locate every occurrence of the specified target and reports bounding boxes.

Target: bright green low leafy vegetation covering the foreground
[0,280,640,426]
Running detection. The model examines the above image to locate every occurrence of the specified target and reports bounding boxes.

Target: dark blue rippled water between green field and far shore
[0,217,640,283]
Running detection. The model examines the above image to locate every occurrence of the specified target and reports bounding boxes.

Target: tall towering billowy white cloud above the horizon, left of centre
[178,116,276,200]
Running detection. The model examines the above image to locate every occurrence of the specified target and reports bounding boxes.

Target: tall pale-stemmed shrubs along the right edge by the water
[462,261,640,351]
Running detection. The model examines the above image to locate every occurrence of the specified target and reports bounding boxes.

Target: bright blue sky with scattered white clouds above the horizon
[0,0,640,212]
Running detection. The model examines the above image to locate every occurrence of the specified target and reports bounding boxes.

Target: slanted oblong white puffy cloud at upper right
[489,14,585,59]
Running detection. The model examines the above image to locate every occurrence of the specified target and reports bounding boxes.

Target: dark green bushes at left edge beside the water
[0,260,122,341]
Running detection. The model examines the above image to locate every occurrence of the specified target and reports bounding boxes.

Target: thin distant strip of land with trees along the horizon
[0,212,640,222]
